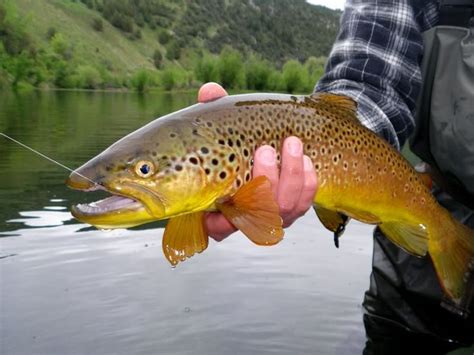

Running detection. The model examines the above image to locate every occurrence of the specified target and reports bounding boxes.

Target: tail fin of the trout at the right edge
[428,215,474,305]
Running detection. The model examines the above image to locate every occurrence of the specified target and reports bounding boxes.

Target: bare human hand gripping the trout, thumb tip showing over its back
[198,83,317,241]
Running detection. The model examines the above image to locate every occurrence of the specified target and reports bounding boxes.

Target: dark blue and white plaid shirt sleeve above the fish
[315,0,438,149]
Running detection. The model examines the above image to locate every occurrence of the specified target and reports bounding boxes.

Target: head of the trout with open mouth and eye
[66,117,231,229]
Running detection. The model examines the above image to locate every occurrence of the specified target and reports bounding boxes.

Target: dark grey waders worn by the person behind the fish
[363,0,474,354]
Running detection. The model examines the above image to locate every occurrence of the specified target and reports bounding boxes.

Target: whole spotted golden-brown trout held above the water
[67,93,474,302]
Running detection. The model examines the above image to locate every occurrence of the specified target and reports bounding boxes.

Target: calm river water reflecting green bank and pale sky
[0,92,470,355]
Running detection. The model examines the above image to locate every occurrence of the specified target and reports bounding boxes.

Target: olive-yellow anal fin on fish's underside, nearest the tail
[379,222,428,256]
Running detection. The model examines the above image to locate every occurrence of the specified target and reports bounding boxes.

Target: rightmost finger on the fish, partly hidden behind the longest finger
[287,155,318,224]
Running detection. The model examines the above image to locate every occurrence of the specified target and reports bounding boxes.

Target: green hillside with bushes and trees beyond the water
[0,0,340,90]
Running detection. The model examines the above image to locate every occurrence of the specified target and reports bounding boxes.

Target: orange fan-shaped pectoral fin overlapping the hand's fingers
[216,176,284,245]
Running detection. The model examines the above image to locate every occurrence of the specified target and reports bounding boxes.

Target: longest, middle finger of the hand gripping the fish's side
[278,137,304,226]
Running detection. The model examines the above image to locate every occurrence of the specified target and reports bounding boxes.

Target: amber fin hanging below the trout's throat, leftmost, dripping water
[163,212,209,265]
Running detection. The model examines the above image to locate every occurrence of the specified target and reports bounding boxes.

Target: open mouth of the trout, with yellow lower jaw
[66,176,157,229]
